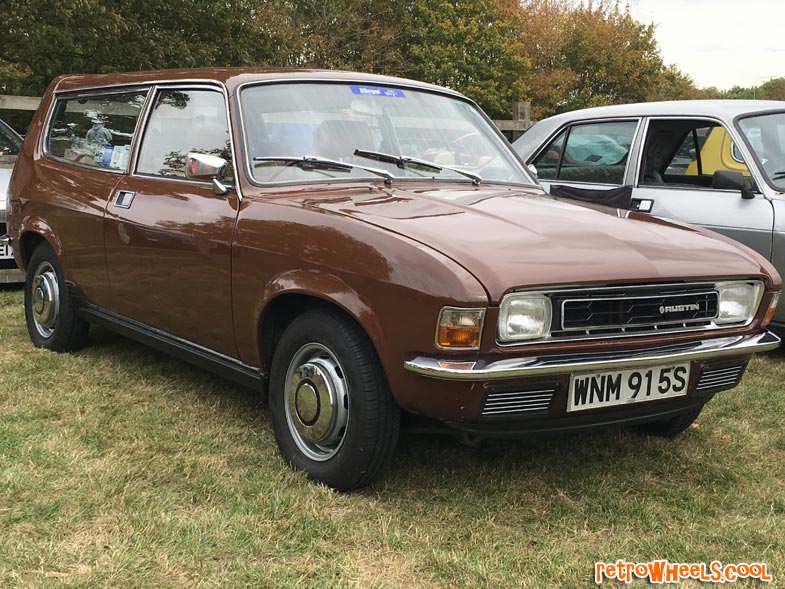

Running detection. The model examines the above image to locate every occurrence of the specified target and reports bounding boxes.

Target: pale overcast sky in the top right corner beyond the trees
[628,0,785,90]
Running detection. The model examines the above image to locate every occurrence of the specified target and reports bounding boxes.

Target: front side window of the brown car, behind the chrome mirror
[136,90,232,178]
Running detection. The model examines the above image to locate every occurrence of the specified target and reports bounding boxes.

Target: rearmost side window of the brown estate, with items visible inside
[46,90,147,170]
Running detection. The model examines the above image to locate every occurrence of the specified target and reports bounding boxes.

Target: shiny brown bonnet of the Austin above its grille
[298,187,766,302]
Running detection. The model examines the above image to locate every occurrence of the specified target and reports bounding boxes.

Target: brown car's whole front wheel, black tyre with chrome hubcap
[269,311,400,491]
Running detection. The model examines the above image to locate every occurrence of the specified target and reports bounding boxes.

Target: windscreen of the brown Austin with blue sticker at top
[240,83,534,185]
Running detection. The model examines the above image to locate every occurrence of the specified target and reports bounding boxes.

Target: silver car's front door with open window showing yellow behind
[632,117,774,259]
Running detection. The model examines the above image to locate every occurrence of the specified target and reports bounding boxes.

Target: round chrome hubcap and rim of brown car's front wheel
[285,343,349,461]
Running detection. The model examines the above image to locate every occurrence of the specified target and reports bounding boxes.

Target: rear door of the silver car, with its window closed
[531,119,639,208]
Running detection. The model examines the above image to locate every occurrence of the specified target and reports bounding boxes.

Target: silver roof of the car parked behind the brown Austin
[515,99,785,159]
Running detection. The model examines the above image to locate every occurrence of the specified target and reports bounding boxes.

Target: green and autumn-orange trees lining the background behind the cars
[0,0,740,123]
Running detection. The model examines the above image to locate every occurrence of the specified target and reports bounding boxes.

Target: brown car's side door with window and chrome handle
[104,86,238,357]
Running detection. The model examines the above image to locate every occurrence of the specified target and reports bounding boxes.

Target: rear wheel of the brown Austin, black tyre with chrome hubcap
[25,242,90,352]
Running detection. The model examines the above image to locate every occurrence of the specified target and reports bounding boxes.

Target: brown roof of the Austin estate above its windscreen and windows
[54,68,458,95]
